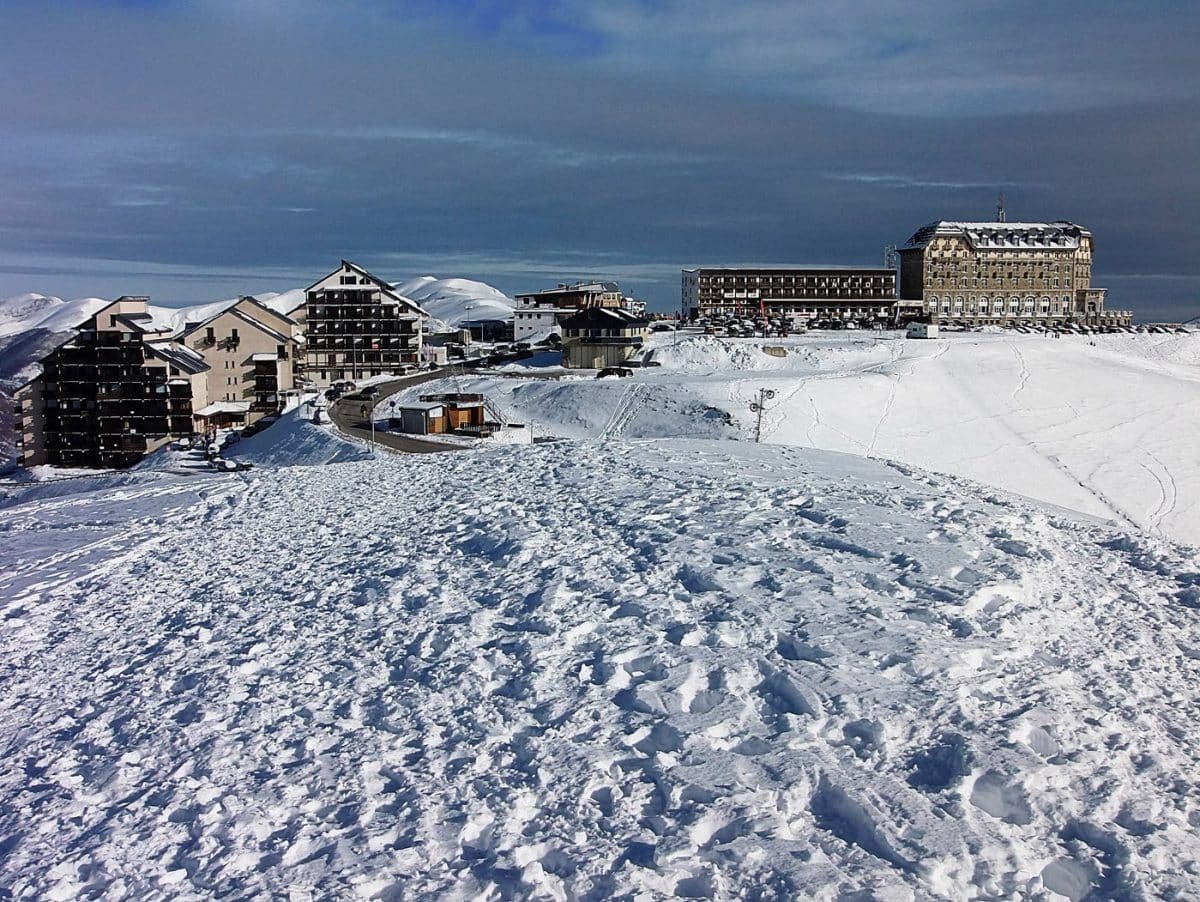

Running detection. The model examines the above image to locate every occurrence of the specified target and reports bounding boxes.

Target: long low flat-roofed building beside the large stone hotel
[682,266,896,320]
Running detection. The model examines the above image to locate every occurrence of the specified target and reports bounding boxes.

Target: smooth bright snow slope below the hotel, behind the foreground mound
[408,332,1200,545]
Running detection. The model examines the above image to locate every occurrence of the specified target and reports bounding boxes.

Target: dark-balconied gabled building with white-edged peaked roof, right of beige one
[304,260,428,387]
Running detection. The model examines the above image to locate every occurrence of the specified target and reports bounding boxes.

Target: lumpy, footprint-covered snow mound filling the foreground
[0,441,1200,898]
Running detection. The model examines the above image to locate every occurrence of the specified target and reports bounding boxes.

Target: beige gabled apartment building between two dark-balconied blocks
[178,297,304,432]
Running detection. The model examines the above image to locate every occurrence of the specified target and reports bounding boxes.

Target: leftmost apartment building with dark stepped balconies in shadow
[14,296,209,468]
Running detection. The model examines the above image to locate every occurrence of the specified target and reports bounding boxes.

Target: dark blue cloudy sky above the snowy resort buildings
[0,0,1200,320]
